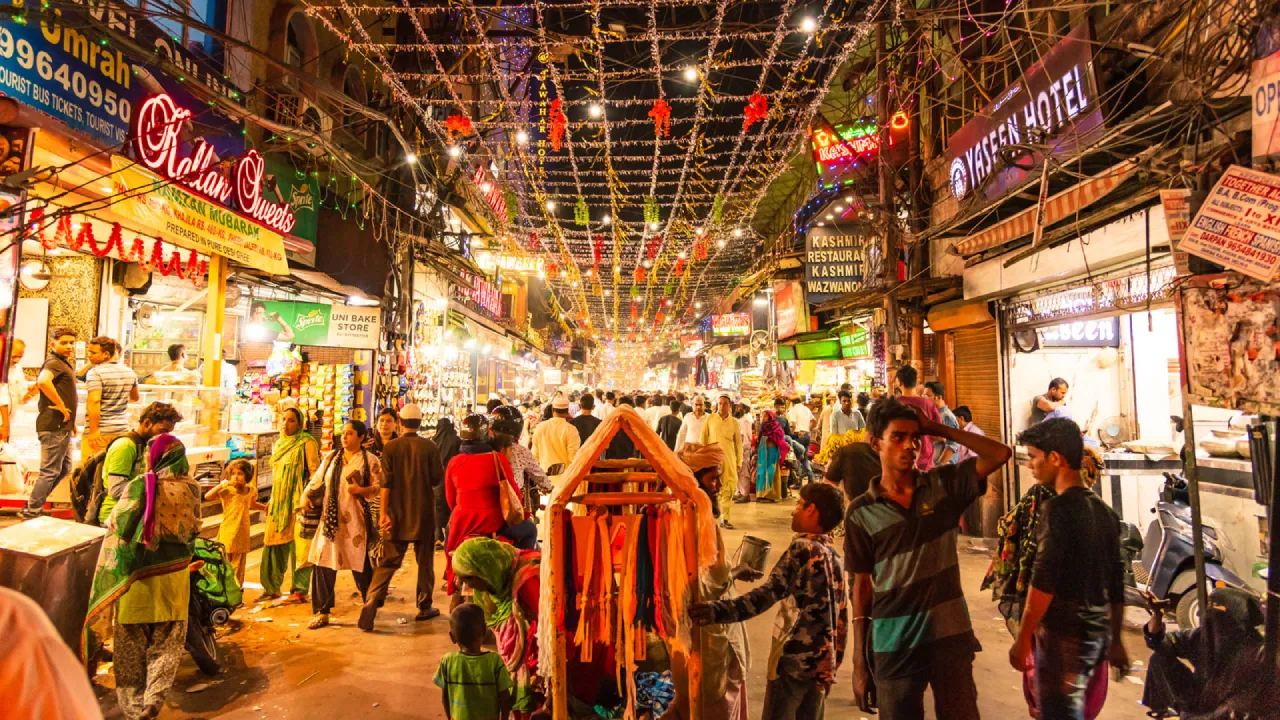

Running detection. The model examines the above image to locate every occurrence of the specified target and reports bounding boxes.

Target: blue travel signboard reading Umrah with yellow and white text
[0,0,244,156]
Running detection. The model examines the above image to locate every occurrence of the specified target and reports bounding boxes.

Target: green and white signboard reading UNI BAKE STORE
[246,300,381,350]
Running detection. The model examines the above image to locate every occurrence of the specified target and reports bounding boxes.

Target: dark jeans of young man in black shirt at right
[1036,626,1111,720]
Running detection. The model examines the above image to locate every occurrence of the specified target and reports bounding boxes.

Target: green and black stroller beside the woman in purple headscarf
[186,538,242,675]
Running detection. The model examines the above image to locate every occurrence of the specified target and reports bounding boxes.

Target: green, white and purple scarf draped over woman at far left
[81,434,200,660]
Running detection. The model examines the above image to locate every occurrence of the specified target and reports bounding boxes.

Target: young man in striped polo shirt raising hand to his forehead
[845,400,1012,720]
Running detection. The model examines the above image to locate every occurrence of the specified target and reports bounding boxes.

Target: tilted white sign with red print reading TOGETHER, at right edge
[1178,165,1280,281]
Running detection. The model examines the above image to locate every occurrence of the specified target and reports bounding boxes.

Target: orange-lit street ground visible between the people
[85,491,1147,720]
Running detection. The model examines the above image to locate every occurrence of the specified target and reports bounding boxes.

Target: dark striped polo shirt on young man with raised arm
[845,459,987,679]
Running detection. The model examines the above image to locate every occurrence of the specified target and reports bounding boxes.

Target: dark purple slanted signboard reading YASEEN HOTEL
[947,23,1103,200]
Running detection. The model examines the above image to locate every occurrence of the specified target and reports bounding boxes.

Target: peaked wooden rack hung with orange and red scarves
[538,406,717,720]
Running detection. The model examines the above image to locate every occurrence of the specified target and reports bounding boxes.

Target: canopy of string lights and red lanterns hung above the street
[307,0,888,340]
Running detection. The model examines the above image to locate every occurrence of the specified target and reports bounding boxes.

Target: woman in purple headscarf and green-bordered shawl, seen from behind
[82,434,200,720]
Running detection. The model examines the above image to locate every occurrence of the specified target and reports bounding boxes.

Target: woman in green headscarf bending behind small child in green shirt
[453,538,543,717]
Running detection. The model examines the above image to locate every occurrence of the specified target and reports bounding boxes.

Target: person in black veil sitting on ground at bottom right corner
[1142,588,1280,720]
